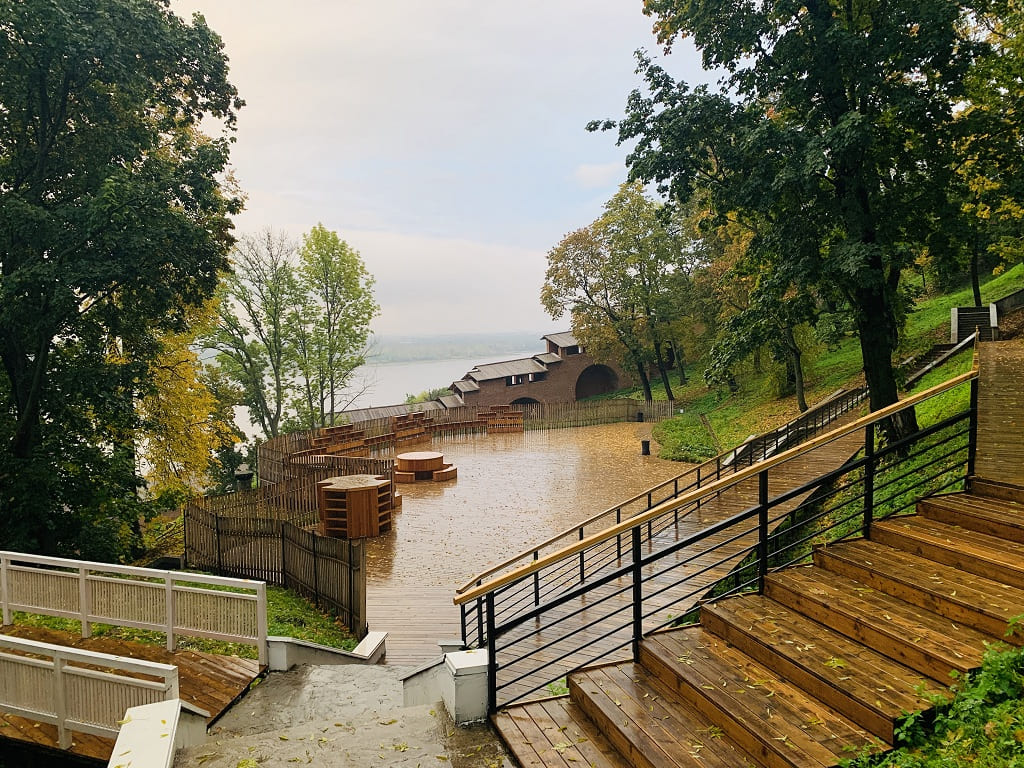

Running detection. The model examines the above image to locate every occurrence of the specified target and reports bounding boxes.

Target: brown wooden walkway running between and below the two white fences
[0,625,262,766]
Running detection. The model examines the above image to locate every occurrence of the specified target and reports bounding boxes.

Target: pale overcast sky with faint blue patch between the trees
[172,0,706,335]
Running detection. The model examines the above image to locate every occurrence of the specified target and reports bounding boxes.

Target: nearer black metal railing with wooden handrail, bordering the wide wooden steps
[457,372,977,711]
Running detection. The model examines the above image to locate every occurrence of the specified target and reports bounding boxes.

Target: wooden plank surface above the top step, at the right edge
[975,338,1024,485]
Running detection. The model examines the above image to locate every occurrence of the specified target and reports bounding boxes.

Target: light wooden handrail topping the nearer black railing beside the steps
[454,368,978,605]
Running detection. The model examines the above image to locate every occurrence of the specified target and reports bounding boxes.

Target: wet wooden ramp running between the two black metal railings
[498,421,863,706]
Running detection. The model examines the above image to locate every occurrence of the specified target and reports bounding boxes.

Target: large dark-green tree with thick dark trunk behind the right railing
[590,0,982,436]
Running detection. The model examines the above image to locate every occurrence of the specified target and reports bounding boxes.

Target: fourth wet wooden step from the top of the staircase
[814,540,1024,645]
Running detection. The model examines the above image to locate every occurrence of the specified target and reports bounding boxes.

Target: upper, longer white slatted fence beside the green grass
[0,551,267,667]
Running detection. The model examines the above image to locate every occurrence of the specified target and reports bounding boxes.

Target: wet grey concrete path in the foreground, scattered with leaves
[174,666,512,768]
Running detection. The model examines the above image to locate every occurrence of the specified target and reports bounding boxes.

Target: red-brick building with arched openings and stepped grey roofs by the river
[448,332,633,408]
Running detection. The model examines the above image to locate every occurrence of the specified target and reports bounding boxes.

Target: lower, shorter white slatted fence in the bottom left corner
[0,635,178,750]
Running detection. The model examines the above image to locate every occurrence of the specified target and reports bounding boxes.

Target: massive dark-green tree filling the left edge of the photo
[0,0,242,558]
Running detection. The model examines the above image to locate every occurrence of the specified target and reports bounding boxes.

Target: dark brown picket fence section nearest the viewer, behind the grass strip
[184,507,367,639]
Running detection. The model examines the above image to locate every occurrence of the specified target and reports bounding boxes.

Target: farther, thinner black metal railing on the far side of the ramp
[456,388,866,647]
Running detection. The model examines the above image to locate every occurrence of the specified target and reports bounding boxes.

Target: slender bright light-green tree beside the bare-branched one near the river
[289,224,380,429]
